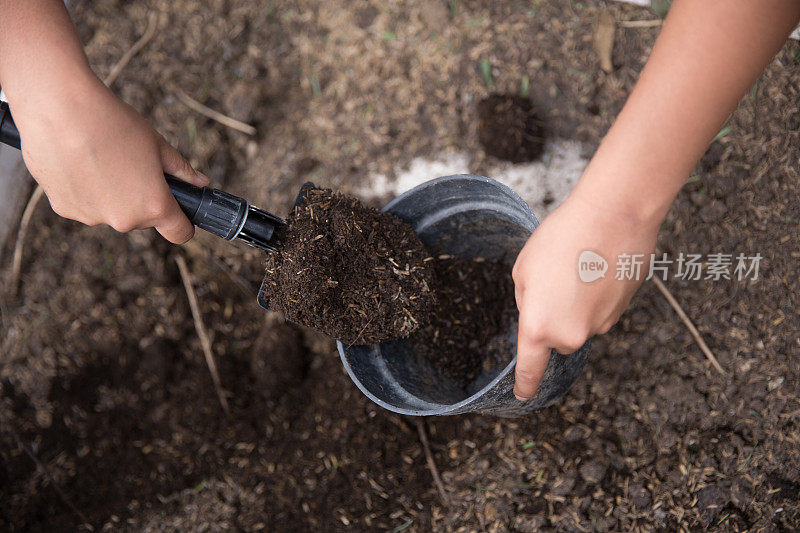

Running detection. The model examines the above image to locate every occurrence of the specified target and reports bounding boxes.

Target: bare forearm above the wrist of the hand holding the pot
[576,0,800,225]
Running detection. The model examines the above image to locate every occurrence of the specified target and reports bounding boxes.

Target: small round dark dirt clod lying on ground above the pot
[478,94,544,163]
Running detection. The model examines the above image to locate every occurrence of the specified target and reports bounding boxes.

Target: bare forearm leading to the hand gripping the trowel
[0,0,97,111]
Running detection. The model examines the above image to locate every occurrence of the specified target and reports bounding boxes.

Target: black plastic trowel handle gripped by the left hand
[0,102,284,250]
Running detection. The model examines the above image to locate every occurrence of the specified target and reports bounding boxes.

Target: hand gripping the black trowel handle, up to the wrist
[12,75,209,244]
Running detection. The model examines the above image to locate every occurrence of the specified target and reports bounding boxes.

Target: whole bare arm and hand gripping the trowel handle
[0,0,208,244]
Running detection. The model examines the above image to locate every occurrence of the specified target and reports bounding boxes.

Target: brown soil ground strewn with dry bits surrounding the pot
[0,0,800,531]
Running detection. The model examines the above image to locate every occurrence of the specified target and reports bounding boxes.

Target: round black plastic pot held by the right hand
[337,174,589,417]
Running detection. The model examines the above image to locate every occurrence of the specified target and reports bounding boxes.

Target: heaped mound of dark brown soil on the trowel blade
[264,187,435,344]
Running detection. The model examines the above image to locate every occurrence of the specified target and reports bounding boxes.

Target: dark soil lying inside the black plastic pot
[411,255,517,388]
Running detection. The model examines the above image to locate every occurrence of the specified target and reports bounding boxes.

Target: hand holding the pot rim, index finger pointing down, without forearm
[513,191,658,401]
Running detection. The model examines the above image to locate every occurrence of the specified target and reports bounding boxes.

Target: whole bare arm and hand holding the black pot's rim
[513,0,800,400]
